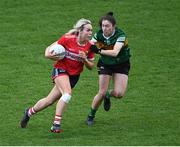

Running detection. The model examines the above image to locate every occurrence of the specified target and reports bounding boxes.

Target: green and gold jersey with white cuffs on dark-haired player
[93,28,131,65]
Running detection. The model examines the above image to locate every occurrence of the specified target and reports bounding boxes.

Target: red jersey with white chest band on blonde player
[54,34,94,75]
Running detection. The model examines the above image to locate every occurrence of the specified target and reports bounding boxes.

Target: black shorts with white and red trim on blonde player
[52,68,80,88]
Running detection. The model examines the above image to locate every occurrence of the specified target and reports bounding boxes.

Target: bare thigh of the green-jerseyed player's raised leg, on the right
[113,73,128,95]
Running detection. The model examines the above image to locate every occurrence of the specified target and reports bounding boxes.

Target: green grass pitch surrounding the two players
[0,0,180,146]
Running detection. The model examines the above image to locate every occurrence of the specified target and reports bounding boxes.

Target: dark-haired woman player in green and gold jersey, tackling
[86,12,131,125]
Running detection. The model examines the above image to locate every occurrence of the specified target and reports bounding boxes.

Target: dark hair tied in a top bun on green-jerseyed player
[99,12,116,27]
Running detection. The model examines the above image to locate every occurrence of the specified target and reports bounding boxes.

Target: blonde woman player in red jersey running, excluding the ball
[20,18,94,133]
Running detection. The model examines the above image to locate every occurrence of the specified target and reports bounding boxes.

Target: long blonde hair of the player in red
[67,18,91,35]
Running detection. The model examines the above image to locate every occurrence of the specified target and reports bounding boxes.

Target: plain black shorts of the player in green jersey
[97,60,130,76]
